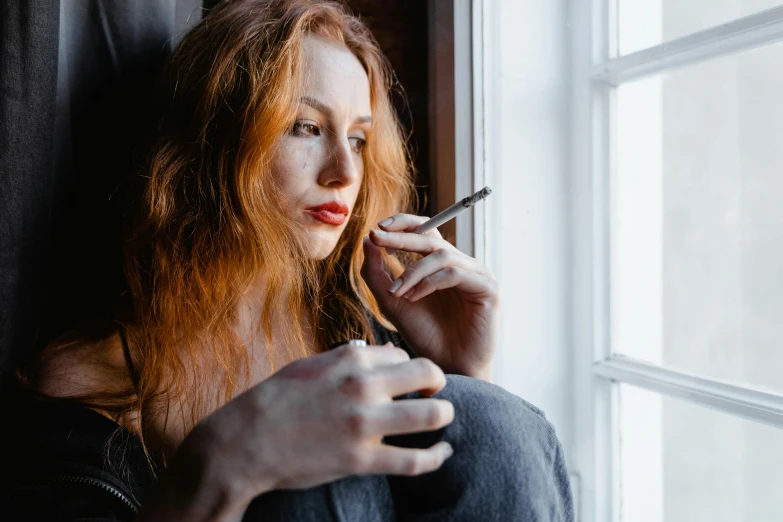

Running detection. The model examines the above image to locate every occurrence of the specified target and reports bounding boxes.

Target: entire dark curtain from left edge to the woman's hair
[0,0,201,393]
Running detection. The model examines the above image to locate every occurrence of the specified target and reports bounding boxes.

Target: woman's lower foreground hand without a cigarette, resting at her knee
[168,343,454,512]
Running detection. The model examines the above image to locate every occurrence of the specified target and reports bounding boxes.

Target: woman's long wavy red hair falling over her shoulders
[21,0,416,462]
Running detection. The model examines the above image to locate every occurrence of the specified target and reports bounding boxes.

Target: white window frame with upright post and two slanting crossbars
[570,4,783,522]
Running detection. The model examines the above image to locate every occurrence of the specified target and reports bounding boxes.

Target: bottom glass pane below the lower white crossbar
[617,384,783,522]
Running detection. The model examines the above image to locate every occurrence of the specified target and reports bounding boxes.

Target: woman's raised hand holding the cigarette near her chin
[362,214,500,380]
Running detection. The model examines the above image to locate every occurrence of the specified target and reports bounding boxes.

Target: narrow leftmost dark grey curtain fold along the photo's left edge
[0,0,60,398]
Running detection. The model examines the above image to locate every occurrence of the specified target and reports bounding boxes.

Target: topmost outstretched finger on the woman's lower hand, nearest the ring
[371,357,446,397]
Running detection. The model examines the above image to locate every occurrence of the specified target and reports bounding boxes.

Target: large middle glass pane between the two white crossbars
[611,39,783,391]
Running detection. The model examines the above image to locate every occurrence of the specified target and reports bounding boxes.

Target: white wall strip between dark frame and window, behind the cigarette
[483,0,574,462]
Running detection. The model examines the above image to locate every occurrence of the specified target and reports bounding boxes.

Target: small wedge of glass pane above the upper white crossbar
[617,0,783,54]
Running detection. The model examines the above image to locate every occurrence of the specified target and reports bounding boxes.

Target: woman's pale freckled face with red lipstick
[272,36,371,259]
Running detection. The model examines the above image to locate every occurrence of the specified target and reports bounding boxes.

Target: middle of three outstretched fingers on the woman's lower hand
[366,399,454,436]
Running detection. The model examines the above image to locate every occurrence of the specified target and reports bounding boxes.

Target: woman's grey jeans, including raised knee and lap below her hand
[243,375,574,522]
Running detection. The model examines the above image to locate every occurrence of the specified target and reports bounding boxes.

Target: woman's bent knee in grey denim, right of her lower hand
[392,375,573,521]
